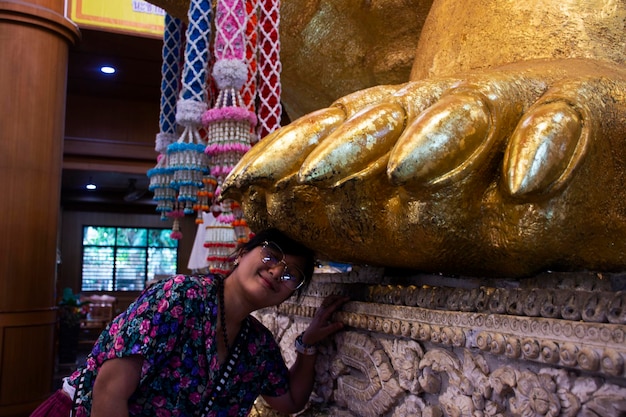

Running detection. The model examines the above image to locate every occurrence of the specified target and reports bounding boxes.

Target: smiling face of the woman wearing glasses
[230,242,305,308]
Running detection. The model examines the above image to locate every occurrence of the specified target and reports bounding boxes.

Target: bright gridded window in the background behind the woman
[81,226,178,291]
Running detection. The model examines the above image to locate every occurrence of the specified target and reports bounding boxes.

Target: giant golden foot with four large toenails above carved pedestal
[222,59,626,277]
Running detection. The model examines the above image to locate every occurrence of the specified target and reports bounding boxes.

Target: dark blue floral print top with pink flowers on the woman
[69,275,289,417]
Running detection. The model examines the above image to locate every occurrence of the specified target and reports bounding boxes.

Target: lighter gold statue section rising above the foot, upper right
[411,0,626,80]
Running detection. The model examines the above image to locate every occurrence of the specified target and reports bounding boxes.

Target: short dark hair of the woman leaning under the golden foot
[239,228,315,294]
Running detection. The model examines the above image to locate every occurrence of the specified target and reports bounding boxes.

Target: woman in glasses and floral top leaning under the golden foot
[32,229,347,417]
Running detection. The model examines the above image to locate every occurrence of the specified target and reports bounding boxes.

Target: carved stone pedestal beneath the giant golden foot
[252,269,626,417]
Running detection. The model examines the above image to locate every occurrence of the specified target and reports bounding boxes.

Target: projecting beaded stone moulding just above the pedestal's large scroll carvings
[281,303,626,376]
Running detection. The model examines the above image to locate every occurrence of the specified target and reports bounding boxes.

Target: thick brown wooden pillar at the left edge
[0,0,78,417]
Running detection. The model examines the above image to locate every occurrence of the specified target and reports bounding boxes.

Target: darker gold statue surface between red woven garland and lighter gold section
[150,0,432,120]
